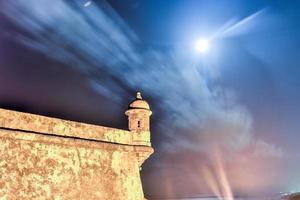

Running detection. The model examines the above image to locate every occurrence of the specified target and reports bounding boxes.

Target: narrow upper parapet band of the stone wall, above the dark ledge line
[0,108,132,144]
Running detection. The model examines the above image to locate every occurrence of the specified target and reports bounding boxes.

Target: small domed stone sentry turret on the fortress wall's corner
[125,92,152,146]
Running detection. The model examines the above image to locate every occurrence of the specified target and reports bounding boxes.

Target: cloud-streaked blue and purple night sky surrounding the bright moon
[0,0,300,197]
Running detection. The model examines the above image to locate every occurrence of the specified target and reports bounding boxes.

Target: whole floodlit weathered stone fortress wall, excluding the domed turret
[0,109,153,200]
